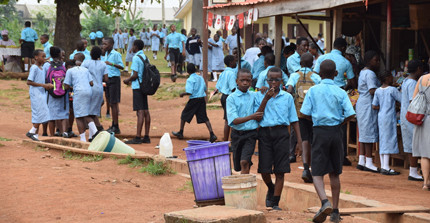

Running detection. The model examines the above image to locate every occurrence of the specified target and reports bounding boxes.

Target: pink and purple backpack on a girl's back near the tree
[45,61,67,109]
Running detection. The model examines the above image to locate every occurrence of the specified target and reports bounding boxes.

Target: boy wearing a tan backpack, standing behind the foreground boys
[286,53,321,183]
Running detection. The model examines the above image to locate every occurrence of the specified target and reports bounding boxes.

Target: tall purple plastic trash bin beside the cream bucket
[184,142,231,202]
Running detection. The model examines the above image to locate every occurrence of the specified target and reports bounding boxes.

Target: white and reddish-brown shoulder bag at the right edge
[406,79,430,125]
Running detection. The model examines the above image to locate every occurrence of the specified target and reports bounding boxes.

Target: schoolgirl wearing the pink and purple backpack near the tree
[43,46,69,138]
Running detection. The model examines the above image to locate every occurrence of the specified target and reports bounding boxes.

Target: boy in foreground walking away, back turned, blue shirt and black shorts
[300,60,355,222]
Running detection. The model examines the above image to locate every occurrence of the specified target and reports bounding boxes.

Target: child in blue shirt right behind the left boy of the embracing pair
[215,55,237,141]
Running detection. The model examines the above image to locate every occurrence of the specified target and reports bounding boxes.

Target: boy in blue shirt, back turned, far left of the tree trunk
[19,21,38,71]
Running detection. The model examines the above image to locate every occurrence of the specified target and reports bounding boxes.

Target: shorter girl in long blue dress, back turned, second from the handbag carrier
[372,72,402,175]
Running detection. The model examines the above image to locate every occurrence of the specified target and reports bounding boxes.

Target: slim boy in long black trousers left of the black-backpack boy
[103,37,124,134]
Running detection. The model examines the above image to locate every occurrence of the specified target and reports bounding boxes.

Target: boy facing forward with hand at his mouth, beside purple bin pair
[255,67,302,210]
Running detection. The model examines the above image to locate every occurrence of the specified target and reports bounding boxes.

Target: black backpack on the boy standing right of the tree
[137,55,160,95]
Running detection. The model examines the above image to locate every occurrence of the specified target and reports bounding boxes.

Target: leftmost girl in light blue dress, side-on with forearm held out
[26,50,54,141]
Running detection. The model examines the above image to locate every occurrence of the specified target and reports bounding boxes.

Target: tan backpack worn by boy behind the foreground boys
[294,71,315,118]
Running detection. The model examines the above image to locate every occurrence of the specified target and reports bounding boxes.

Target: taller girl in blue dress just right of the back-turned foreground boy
[355,51,381,172]
